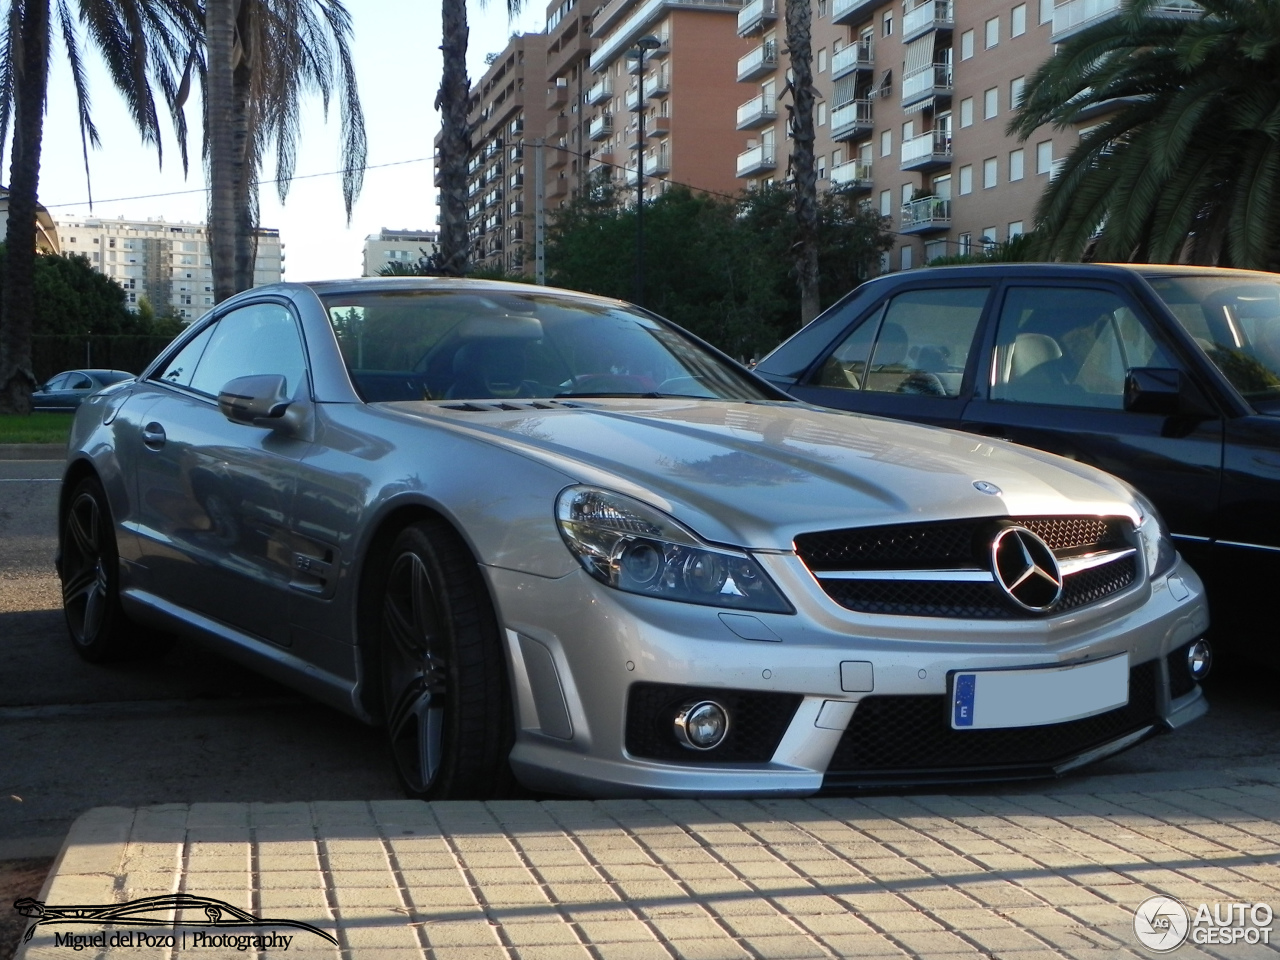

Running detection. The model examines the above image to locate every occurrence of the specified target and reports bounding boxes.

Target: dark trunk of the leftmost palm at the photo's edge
[0,0,50,413]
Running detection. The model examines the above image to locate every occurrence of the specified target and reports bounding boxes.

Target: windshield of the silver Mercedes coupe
[321,291,773,402]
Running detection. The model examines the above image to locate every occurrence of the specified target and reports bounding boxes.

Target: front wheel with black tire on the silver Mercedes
[378,520,513,800]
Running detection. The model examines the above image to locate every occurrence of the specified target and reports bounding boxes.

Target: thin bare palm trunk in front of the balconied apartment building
[786,0,822,325]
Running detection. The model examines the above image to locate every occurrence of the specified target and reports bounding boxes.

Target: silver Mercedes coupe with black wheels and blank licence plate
[58,279,1210,797]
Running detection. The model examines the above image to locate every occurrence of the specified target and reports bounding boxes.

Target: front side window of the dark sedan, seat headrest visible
[991,287,1176,410]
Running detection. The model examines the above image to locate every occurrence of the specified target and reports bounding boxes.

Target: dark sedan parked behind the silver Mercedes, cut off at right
[755,264,1280,663]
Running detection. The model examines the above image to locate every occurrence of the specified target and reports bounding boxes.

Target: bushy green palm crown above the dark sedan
[1010,0,1280,270]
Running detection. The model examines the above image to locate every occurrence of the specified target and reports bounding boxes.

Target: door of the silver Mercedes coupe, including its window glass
[128,301,311,644]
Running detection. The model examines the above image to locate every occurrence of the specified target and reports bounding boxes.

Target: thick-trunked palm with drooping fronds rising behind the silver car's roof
[197,0,367,301]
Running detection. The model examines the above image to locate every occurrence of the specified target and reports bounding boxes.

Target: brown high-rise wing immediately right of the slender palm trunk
[450,33,547,273]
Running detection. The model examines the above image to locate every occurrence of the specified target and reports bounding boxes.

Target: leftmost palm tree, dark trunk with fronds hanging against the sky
[0,0,192,413]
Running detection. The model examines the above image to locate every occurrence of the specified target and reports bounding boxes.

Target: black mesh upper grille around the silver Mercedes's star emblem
[795,517,1138,620]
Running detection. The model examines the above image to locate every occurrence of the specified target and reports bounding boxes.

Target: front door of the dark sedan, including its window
[964,279,1224,557]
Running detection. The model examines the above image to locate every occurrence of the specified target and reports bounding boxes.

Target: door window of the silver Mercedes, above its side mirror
[191,303,306,397]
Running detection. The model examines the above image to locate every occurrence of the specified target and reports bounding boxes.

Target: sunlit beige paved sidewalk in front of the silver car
[18,781,1280,960]
